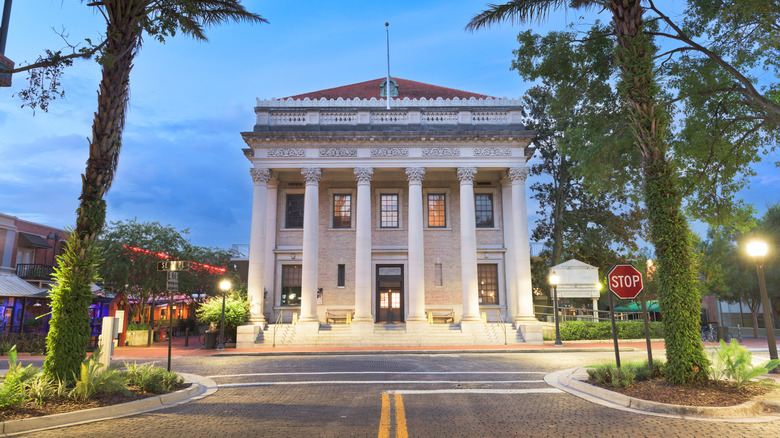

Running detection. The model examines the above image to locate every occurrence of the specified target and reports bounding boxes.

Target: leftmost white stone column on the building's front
[247,168,271,325]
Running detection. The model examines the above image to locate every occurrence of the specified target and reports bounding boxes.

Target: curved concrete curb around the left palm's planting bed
[0,373,217,436]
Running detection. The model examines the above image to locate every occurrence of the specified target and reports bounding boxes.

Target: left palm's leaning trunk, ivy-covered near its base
[44,5,140,381]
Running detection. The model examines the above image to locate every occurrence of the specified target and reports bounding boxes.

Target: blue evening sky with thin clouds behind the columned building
[0,0,780,248]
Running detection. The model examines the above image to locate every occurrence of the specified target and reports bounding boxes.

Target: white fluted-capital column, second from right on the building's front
[458,167,482,322]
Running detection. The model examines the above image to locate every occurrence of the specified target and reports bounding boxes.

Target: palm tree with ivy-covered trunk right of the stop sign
[466,0,708,383]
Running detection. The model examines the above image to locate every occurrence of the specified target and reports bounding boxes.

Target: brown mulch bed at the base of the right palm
[588,378,774,407]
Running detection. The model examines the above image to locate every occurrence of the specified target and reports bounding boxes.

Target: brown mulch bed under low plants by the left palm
[0,383,190,421]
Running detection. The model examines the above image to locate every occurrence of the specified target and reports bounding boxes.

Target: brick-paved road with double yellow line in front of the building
[10,352,780,438]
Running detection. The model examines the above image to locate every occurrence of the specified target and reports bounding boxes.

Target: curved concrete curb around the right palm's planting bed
[544,367,780,422]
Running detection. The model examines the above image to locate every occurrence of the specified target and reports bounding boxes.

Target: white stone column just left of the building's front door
[352,167,374,327]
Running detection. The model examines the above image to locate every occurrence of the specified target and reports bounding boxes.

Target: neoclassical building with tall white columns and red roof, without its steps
[238,78,541,346]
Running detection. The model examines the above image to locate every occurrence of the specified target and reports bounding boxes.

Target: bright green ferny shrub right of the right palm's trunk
[710,339,780,386]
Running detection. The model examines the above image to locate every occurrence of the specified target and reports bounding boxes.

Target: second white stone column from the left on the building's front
[298,168,322,323]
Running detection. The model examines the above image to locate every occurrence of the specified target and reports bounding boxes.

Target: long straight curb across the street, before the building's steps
[209,347,638,357]
